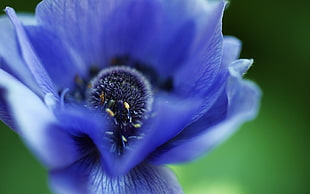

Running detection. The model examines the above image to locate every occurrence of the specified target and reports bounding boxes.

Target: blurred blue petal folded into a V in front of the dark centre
[56,95,202,176]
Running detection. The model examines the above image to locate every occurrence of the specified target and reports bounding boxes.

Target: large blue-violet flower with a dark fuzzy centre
[0,0,260,193]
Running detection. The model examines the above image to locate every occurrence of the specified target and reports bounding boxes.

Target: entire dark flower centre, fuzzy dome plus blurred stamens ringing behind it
[63,55,174,156]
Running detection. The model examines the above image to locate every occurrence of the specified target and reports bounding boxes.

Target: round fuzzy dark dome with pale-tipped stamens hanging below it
[86,66,153,154]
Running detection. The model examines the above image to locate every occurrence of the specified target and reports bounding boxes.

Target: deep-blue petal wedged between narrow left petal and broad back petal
[25,26,88,89]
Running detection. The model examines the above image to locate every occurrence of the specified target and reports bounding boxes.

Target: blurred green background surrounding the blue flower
[0,0,310,194]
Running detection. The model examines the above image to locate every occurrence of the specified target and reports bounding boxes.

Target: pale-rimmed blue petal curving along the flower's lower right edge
[152,60,261,164]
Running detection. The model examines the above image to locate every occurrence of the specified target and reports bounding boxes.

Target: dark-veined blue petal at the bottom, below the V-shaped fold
[50,162,183,194]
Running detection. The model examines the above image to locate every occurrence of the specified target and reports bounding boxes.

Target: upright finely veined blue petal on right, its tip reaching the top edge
[170,1,229,124]
